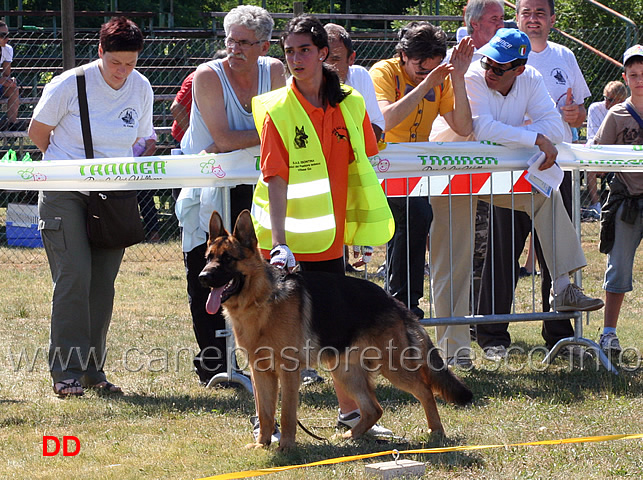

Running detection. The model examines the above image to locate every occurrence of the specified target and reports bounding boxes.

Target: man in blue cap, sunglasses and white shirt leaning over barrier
[436,28,603,364]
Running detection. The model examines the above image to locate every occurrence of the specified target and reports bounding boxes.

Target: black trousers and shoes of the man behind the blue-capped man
[476,172,574,348]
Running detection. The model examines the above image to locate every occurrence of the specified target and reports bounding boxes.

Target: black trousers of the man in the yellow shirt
[386,197,433,308]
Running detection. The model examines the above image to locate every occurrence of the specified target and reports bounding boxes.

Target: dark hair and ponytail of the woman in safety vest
[279,15,348,107]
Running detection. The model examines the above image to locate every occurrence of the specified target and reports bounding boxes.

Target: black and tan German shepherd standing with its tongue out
[200,210,473,450]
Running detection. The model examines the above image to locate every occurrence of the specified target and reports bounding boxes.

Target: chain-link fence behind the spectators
[0,22,635,263]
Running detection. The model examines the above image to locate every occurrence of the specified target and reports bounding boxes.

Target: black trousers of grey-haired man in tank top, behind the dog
[183,185,252,383]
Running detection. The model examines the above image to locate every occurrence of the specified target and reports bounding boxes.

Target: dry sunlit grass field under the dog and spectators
[0,239,643,480]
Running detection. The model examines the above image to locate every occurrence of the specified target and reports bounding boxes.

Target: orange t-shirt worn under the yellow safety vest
[261,80,379,262]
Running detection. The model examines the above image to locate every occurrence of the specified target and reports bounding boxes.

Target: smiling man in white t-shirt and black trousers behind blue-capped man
[477,0,590,354]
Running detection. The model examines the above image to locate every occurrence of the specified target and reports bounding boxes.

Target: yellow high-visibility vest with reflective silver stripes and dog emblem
[252,87,395,253]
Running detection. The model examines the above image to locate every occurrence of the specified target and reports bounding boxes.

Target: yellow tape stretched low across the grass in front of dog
[199,433,643,480]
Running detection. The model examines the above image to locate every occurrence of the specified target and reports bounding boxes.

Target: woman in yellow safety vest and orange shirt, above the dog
[252,16,394,274]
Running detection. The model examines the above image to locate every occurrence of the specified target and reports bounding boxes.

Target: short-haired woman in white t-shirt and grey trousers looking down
[29,17,154,397]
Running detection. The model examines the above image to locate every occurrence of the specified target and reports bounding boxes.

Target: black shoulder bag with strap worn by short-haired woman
[75,67,145,248]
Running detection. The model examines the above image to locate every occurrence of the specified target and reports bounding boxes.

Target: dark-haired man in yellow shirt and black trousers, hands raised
[369,22,474,318]
